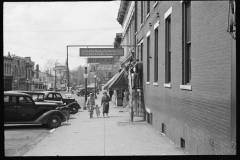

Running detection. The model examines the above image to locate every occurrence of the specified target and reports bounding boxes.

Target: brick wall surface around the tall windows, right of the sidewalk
[137,1,231,154]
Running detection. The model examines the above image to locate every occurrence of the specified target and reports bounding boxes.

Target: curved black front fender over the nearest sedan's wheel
[35,110,66,124]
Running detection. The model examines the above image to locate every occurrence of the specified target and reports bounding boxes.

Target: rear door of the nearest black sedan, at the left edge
[4,95,18,122]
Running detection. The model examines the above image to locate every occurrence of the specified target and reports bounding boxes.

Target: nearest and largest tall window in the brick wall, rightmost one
[182,2,191,84]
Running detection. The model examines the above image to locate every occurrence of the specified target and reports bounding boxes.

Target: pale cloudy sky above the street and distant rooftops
[3,1,123,70]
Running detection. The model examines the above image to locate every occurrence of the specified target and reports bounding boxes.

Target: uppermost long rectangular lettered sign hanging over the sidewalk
[80,48,124,56]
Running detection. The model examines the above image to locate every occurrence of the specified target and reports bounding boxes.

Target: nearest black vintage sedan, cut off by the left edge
[4,92,67,128]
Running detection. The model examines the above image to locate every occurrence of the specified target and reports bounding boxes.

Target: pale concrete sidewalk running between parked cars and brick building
[23,92,186,156]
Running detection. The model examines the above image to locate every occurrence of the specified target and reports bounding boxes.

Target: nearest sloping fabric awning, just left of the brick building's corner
[108,69,128,89]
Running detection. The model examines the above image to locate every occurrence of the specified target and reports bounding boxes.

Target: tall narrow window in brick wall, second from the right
[165,15,171,83]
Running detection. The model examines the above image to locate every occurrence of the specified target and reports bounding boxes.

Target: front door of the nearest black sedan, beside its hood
[18,96,37,121]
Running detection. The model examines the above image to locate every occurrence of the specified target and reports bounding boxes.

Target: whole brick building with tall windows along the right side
[117,1,236,155]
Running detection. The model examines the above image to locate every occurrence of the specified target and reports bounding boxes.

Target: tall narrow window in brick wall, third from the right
[154,28,158,82]
